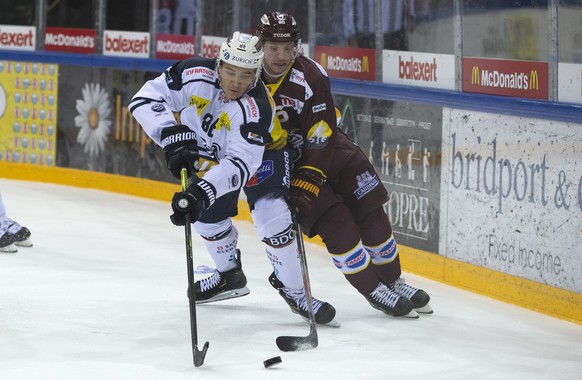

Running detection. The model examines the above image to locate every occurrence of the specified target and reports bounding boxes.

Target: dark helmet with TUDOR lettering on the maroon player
[257,12,301,46]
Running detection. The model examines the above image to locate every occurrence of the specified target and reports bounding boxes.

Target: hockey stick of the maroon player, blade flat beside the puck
[276,218,318,352]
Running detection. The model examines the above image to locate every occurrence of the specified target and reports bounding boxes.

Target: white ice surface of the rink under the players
[0,179,582,380]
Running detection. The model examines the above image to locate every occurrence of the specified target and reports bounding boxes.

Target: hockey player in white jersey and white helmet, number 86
[129,32,335,323]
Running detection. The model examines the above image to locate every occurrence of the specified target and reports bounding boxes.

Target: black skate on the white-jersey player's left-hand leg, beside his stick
[194,249,251,304]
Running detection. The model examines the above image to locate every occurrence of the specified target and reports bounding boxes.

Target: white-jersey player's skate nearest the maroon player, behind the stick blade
[269,272,339,327]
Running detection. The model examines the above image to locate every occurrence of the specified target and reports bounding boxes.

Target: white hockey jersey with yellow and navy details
[129,57,277,198]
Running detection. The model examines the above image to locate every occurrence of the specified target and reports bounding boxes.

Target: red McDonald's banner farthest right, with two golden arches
[463,58,549,100]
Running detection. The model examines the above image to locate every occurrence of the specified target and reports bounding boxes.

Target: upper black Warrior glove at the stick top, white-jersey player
[161,124,199,179]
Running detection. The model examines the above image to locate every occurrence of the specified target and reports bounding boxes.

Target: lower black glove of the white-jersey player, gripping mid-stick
[170,176,216,226]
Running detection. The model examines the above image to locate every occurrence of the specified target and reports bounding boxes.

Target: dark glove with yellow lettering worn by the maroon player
[289,167,325,215]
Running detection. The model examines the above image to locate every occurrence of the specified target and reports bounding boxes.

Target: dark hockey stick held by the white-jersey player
[180,168,208,367]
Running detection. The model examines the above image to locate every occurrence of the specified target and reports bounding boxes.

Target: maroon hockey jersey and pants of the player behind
[267,56,388,236]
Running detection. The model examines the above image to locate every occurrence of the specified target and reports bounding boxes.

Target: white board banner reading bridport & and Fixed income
[441,109,582,293]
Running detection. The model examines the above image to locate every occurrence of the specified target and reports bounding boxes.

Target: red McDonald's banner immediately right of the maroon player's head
[313,46,376,81]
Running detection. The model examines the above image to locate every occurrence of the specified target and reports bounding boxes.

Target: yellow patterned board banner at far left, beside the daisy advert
[0,61,59,166]
